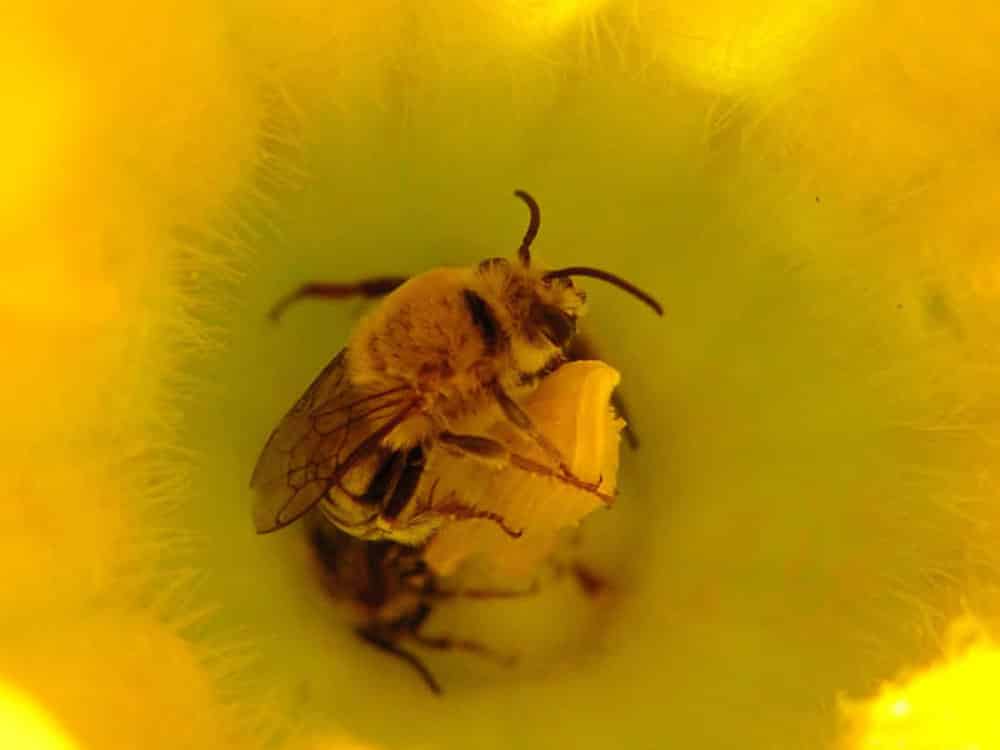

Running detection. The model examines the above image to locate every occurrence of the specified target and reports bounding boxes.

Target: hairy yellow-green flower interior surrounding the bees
[0,0,1000,750]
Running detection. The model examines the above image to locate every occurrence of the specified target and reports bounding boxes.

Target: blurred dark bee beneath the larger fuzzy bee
[309,519,520,694]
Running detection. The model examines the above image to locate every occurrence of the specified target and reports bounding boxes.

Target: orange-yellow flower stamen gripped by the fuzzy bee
[424,360,625,578]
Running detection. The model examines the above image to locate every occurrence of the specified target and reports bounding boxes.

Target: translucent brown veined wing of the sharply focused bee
[250,349,413,534]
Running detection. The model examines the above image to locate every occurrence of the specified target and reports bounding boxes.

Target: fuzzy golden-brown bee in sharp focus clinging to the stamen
[250,190,663,546]
